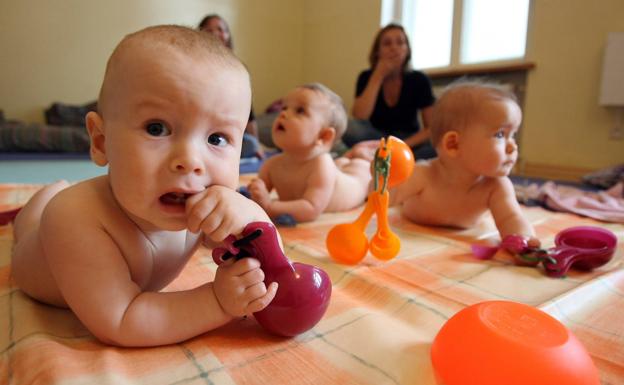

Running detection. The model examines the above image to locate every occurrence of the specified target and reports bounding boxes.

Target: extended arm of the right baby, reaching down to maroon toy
[488,177,540,247]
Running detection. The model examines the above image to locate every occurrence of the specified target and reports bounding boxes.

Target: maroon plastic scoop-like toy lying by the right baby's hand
[473,226,617,277]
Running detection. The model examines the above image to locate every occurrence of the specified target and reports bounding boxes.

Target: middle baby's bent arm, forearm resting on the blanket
[249,156,339,222]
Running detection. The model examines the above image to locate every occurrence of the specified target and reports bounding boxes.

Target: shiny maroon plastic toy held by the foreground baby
[212,222,332,337]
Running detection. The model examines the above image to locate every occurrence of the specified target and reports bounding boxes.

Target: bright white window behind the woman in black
[381,0,530,69]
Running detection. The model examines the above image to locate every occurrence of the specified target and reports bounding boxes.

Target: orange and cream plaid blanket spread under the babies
[0,181,624,385]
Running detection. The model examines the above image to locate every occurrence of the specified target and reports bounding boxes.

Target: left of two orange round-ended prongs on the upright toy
[325,192,375,265]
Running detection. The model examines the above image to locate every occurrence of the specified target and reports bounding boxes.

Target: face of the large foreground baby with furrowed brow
[103,49,251,231]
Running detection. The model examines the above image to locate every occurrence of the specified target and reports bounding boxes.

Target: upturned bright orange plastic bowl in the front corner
[431,301,600,385]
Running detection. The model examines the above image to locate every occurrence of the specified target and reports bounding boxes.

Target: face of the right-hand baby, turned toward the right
[460,99,522,177]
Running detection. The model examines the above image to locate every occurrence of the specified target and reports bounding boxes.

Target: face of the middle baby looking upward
[272,88,329,151]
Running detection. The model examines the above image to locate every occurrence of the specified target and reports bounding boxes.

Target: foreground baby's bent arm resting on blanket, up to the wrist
[40,194,238,346]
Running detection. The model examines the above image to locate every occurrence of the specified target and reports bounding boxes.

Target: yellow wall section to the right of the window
[521,0,624,169]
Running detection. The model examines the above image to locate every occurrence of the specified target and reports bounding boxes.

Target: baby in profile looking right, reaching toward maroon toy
[390,82,539,246]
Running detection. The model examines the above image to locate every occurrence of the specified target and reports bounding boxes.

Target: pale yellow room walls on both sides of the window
[0,0,624,169]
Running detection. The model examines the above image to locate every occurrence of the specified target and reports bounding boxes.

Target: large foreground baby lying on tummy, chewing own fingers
[12,26,277,346]
